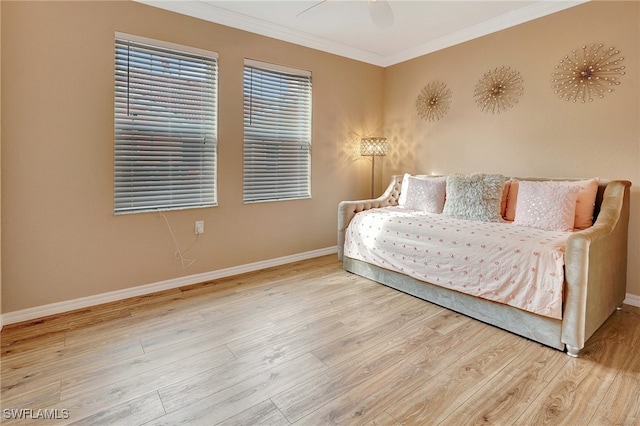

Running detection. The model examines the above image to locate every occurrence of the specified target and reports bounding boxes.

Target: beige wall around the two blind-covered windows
[1,1,384,313]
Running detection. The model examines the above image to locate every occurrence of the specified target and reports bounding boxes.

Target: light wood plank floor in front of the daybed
[1,256,640,426]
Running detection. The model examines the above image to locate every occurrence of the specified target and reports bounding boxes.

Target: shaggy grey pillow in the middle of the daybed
[442,173,505,222]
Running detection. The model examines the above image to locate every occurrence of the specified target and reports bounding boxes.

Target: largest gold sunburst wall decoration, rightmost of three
[551,44,625,103]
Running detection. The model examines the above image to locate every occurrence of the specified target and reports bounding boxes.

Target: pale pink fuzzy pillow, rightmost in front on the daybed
[513,180,580,231]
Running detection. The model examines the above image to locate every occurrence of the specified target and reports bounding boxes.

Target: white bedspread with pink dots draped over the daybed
[344,207,570,319]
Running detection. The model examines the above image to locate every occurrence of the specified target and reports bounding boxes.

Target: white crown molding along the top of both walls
[134,0,589,67]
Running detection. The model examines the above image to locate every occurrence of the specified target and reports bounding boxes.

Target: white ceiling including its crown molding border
[136,0,588,67]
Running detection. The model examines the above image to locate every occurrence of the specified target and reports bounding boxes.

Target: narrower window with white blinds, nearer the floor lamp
[243,60,311,203]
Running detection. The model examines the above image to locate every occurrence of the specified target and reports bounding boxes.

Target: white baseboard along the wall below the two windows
[0,246,338,326]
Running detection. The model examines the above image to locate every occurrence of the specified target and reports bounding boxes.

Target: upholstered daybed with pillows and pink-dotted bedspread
[338,174,631,357]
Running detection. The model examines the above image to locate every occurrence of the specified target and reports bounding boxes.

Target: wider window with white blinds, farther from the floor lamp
[114,34,218,213]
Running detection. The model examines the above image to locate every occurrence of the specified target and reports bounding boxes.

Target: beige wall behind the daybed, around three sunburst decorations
[384,2,640,297]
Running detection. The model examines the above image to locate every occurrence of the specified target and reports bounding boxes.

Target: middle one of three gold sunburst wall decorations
[474,66,524,114]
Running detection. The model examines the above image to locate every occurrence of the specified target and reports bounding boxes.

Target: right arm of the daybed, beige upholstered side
[561,180,631,356]
